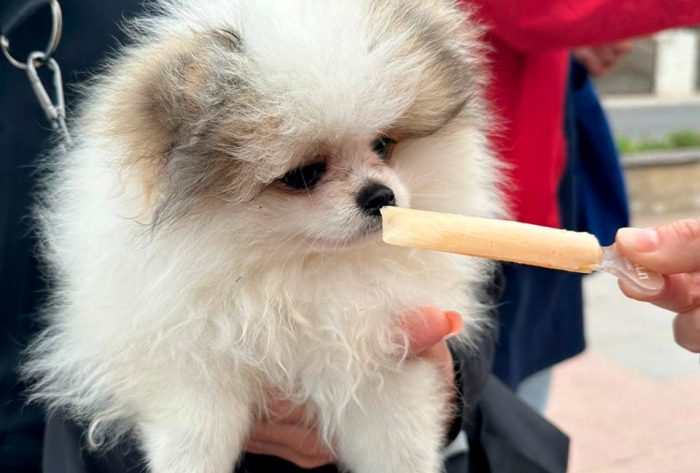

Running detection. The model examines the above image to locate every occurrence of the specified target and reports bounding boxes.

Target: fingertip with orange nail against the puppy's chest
[401,307,463,355]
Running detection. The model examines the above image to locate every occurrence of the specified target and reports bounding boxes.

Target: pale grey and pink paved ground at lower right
[547,212,700,473]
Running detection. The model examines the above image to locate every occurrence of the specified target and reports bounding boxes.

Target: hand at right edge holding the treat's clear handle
[616,219,700,353]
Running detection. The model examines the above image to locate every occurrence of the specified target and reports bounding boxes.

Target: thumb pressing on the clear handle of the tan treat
[616,219,700,274]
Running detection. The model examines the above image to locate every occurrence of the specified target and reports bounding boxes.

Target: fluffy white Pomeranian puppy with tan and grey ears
[25,0,501,473]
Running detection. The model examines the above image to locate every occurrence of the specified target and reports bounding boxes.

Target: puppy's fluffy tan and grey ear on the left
[96,31,240,213]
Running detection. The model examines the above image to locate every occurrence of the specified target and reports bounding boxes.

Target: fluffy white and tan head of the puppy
[95,0,481,254]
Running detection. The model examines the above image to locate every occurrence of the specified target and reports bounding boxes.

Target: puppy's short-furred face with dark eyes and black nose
[250,134,410,249]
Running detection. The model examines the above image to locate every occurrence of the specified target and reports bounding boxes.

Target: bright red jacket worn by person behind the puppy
[462,0,700,227]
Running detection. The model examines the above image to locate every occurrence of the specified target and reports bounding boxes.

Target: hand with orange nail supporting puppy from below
[245,308,463,469]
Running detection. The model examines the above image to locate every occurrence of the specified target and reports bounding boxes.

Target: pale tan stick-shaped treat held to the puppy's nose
[381,207,603,273]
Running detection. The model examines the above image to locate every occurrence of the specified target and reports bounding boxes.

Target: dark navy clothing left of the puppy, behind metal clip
[0,0,146,473]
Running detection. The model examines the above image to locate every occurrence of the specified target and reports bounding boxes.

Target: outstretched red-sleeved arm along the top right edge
[461,0,700,51]
